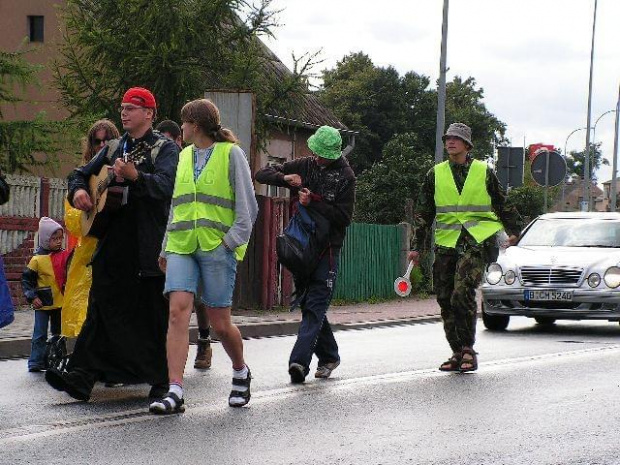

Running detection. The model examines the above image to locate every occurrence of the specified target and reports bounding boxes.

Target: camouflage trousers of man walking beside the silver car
[433,248,486,352]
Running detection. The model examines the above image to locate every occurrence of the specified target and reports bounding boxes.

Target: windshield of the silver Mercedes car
[519,218,620,247]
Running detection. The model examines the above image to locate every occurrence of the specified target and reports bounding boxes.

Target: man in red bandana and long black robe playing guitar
[45,87,179,400]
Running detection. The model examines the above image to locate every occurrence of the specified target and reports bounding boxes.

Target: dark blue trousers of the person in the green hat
[289,249,340,374]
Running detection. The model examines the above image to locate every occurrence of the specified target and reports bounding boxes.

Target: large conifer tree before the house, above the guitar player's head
[54,0,313,147]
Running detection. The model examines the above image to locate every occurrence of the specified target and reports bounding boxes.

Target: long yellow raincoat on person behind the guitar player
[61,202,97,337]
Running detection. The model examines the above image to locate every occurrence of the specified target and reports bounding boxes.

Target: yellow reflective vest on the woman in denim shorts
[166,142,247,261]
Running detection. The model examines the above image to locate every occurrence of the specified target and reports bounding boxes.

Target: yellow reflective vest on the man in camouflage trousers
[434,160,503,248]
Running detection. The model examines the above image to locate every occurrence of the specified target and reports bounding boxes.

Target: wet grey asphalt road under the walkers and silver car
[0,319,620,465]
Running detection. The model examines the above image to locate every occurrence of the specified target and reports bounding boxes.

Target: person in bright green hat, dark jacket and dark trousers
[256,126,355,383]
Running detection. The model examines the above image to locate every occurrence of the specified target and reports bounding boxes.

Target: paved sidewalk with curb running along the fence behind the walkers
[0,297,439,359]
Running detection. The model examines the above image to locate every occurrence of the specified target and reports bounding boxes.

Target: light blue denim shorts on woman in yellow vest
[164,245,237,308]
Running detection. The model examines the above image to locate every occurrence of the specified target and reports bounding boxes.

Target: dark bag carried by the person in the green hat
[276,204,329,278]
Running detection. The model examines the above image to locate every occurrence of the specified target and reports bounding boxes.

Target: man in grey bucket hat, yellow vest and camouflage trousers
[409,123,522,372]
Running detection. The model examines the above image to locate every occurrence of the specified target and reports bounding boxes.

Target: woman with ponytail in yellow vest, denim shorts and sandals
[149,99,258,414]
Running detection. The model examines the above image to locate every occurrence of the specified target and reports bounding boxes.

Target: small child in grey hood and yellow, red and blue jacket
[22,216,70,372]
